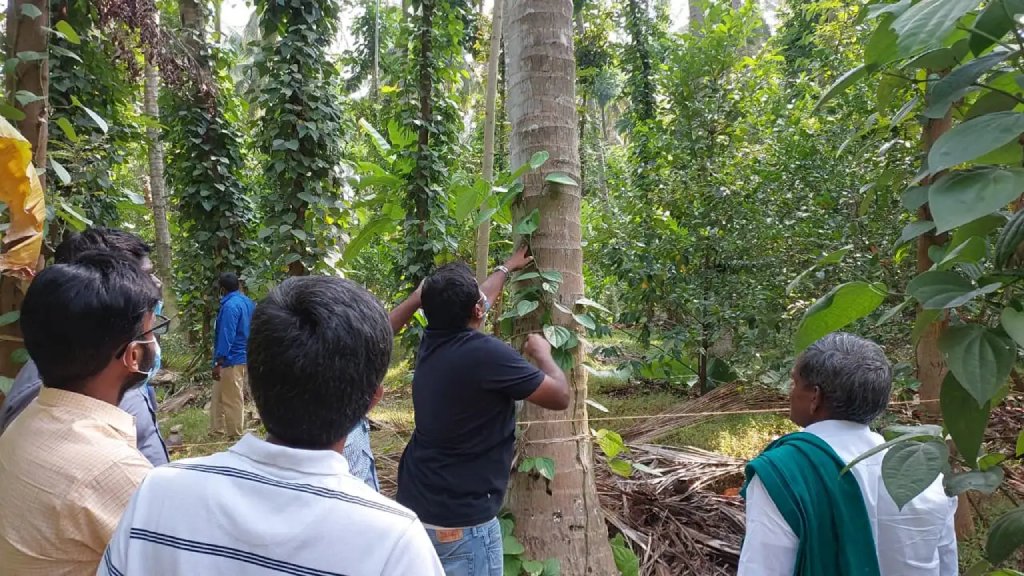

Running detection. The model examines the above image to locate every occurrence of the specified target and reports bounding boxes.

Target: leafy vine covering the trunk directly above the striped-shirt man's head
[255,0,346,276]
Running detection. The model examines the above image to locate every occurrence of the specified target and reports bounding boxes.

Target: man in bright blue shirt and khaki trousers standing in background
[210,272,256,437]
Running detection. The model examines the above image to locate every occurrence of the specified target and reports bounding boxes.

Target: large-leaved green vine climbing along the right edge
[805,0,1024,574]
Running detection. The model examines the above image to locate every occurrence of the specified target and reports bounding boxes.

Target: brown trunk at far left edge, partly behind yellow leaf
[0,0,50,378]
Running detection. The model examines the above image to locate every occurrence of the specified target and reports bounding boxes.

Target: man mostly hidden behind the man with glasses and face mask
[0,227,168,466]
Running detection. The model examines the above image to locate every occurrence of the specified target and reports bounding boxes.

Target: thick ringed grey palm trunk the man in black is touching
[505,0,616,576]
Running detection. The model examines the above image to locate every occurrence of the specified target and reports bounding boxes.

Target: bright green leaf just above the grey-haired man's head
[794,282,886,353]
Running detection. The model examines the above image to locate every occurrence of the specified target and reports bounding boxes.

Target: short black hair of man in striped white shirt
[248,276,393,450]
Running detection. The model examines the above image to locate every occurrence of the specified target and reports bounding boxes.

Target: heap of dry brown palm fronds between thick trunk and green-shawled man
[598,444,745,576]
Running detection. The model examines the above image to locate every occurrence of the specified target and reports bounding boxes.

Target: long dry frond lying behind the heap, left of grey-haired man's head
[621,382,788,443]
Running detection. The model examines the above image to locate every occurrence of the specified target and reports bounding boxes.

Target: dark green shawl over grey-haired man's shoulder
[742,433,881,576]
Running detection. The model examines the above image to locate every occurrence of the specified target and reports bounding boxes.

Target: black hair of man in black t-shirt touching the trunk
[421,262,480,330]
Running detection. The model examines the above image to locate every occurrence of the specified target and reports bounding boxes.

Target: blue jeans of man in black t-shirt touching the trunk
[427,518,505,576]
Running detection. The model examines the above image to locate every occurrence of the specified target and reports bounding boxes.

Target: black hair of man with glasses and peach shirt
[22,250,160,390]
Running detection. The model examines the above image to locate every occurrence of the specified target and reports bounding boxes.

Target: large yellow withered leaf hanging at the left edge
[0,118,46,280]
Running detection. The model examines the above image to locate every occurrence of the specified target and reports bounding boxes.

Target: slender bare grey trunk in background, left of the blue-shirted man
[143,50,177,317]
